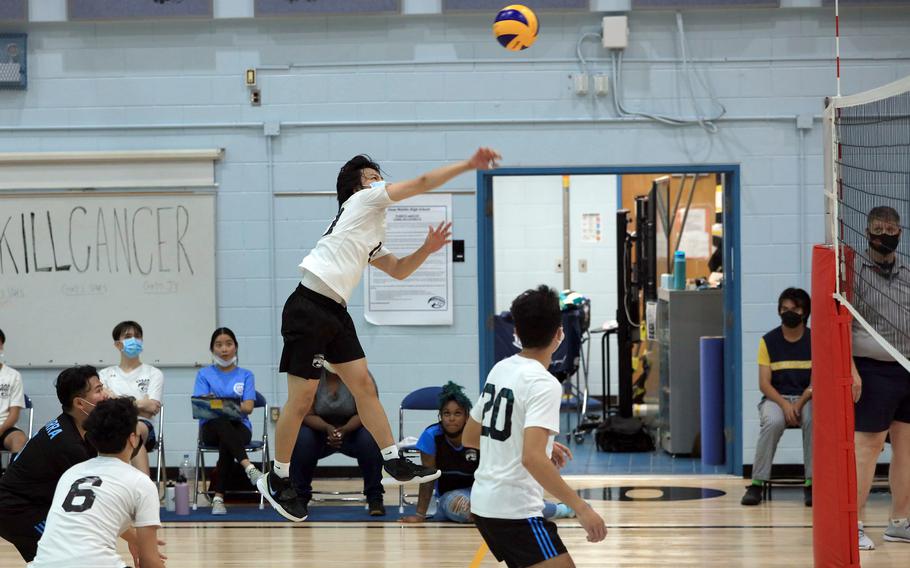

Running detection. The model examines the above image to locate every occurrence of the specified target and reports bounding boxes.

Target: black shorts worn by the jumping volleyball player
[278,284,363,379]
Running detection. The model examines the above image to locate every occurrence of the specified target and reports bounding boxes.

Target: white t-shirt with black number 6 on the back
[29,456,161,568]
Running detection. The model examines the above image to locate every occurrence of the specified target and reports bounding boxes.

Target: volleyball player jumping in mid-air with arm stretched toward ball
[256,148,500,521]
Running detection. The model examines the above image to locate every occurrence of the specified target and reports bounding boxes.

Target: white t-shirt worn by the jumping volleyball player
[300,182,394,302]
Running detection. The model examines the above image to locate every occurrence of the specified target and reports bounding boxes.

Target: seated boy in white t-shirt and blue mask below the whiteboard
[98,321,164,475]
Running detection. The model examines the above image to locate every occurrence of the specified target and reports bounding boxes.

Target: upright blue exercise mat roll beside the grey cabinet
[699,337,724,465]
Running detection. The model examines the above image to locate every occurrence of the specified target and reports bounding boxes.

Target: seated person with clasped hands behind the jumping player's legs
[291,366,385,517]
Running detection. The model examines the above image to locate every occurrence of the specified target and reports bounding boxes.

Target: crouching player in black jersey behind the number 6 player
[0,365,107,562]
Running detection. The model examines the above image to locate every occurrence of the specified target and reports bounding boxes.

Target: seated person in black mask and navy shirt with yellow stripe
[741,288,812,507]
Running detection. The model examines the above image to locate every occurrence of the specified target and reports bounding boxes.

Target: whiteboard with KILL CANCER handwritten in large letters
[0,192,216,368]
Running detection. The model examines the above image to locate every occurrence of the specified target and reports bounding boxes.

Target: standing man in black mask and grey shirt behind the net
[852,206,910,550]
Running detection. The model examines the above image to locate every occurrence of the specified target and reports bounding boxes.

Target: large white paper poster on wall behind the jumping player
[363,194,454,325]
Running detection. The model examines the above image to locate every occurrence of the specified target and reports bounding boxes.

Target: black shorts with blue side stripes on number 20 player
[474,515,567,568]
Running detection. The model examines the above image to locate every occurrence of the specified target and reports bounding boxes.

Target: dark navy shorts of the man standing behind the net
[853,357,910,432]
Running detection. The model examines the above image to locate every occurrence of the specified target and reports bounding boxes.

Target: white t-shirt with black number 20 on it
[471,355,562,519]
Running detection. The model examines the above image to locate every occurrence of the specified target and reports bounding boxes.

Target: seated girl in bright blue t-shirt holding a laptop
[193,327,262,515]
